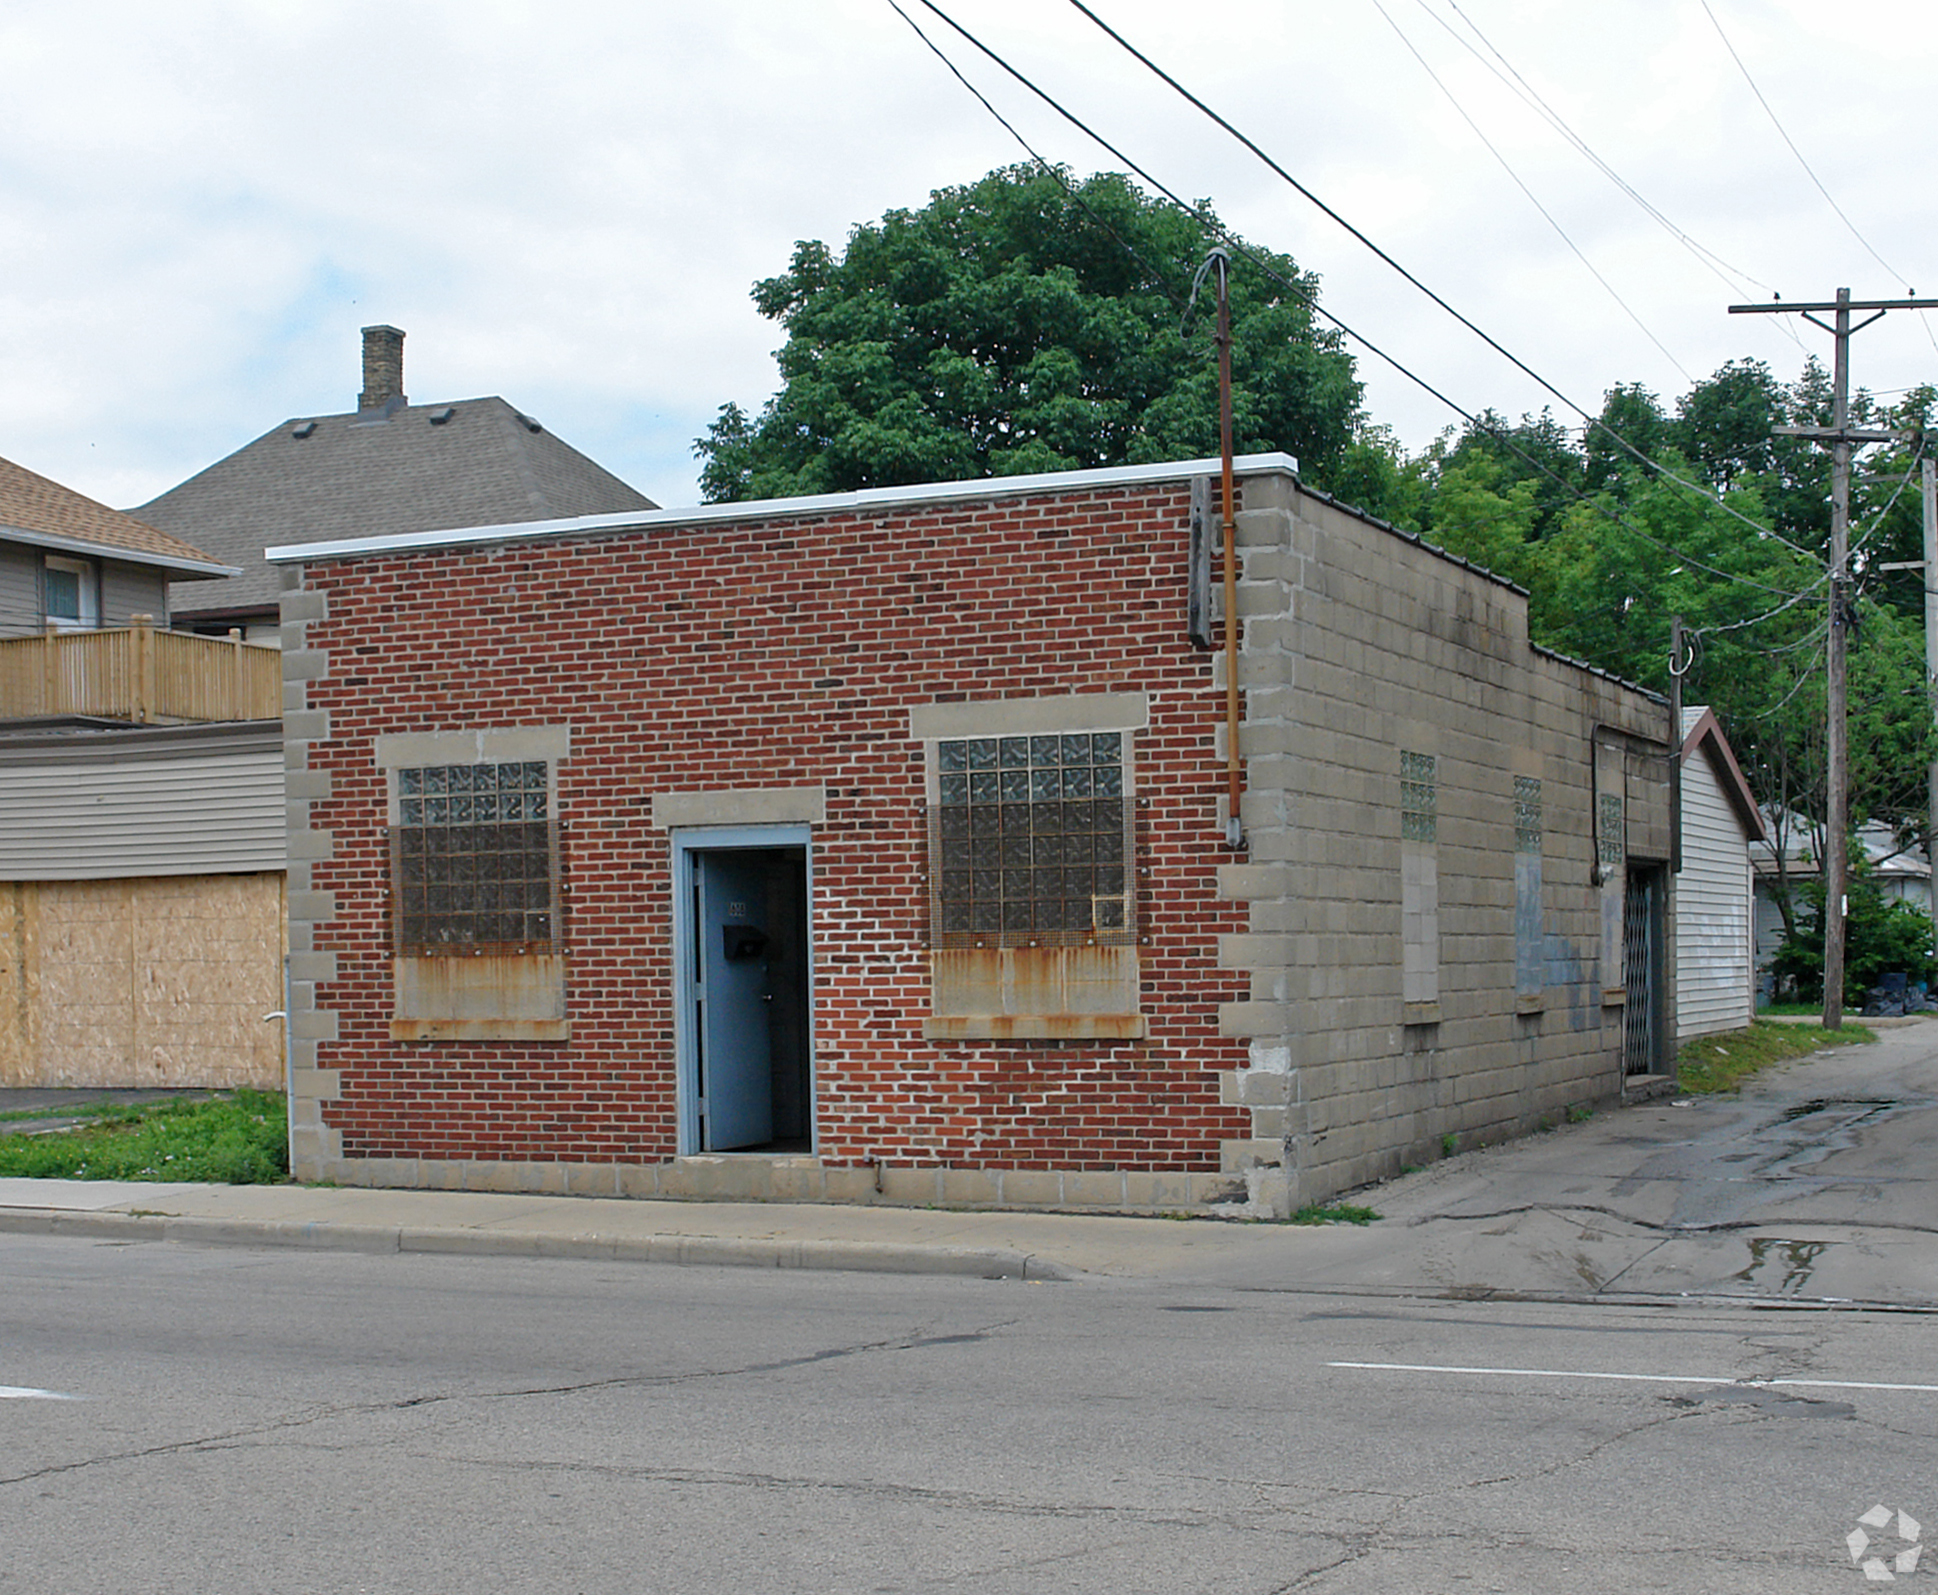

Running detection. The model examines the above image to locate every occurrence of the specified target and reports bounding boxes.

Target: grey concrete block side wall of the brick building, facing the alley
[1219,477,1669,1211]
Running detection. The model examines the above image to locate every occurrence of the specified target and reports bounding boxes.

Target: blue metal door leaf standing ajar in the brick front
[694,849,773,1151]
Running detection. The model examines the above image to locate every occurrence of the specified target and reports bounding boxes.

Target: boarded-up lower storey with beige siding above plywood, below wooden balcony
[0,721,285,1089]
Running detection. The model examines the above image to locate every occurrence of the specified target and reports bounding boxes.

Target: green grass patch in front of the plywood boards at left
[0,1091,289,1186]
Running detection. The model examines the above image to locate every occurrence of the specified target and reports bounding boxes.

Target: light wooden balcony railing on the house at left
[0,616,283,725]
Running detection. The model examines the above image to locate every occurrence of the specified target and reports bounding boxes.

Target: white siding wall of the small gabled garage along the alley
[1676,754,1754,1037]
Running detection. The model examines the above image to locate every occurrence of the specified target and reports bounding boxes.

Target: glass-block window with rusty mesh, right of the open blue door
[928,731,1136,948]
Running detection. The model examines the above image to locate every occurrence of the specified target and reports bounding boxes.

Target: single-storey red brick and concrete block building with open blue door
[269,455,1680,1213]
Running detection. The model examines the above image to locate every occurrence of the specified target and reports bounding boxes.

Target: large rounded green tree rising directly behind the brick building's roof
[694,167,1364,512]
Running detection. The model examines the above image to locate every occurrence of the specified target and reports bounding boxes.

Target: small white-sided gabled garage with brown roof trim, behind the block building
[1676,707,1764,1039]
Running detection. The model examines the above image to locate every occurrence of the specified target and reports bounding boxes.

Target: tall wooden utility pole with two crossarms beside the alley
[1729,289,1938,1031]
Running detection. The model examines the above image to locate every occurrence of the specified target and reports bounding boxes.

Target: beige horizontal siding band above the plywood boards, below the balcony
[0,721,285,880]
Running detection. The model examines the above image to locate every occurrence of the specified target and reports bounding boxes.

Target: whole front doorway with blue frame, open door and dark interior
[676,828,814,1155]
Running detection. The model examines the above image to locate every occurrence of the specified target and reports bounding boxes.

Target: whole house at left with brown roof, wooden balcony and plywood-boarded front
[0,461,283,1087]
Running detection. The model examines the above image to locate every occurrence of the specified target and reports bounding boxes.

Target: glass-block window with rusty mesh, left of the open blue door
[390,760,558,957]
